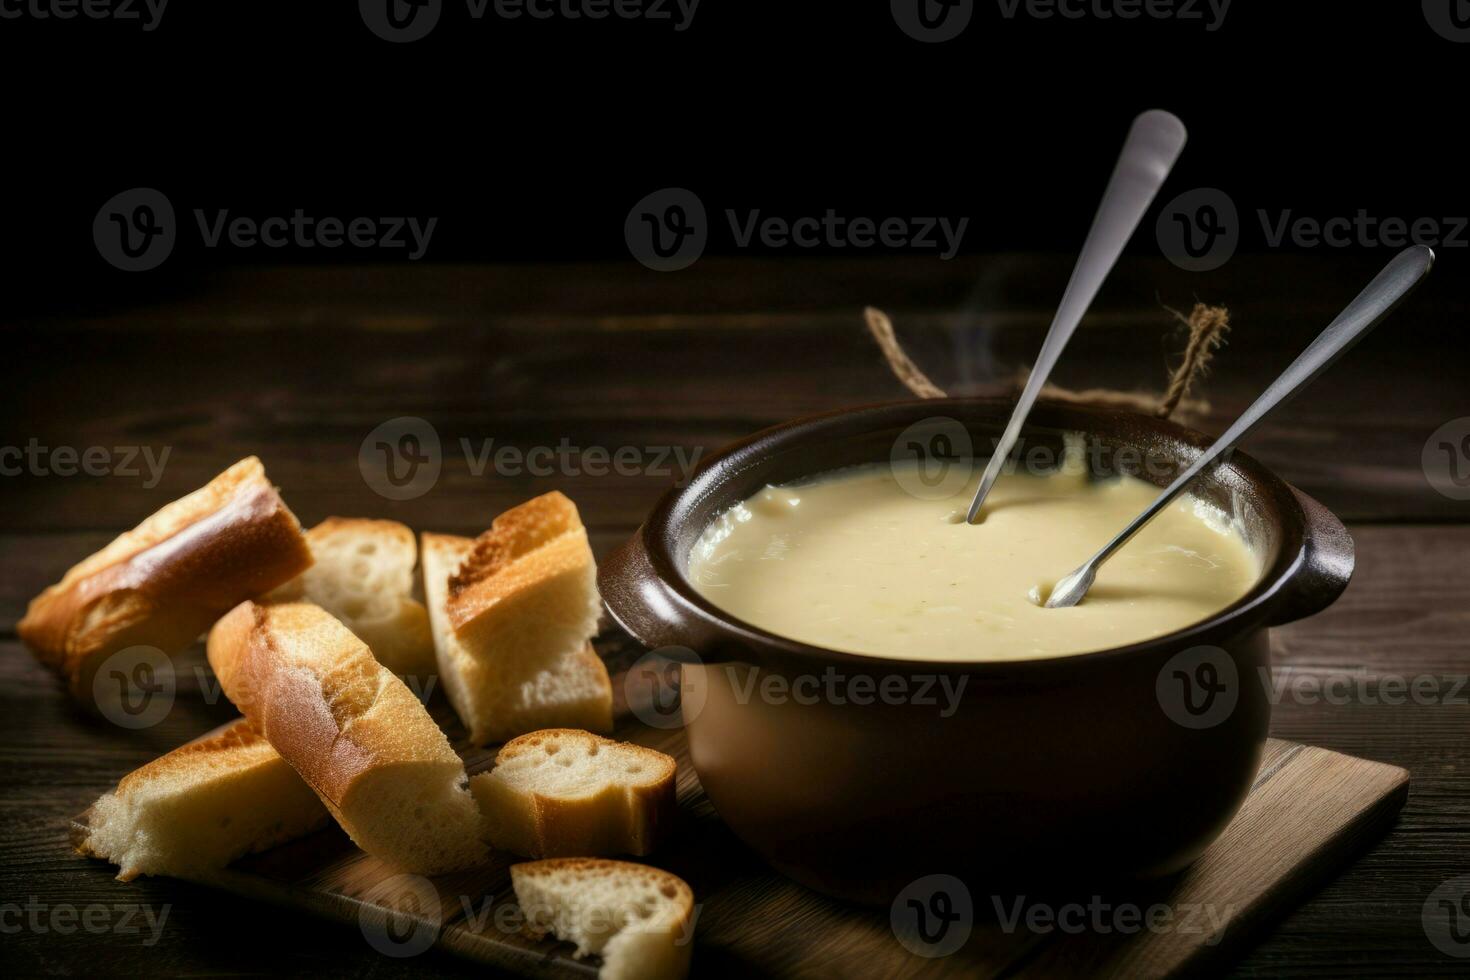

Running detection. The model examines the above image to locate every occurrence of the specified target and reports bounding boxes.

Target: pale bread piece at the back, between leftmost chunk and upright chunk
[266,517,435,677]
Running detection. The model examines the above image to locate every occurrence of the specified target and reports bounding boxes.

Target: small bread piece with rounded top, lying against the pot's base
[469,729,676,858]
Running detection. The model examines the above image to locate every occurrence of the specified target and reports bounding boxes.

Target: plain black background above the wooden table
[0,0,1470,313]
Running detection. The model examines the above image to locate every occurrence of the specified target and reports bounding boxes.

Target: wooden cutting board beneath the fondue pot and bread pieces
[74,643,1408,977]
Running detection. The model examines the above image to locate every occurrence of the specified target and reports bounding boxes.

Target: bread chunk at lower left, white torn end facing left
[74,718,328,882]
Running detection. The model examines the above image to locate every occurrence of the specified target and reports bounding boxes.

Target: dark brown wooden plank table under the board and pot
[0,256,1470,977]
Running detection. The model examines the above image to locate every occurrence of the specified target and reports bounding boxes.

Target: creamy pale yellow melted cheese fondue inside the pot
[688,463,1260,660]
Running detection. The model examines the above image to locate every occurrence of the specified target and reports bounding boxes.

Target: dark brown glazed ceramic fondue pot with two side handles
[598,398,1352,902]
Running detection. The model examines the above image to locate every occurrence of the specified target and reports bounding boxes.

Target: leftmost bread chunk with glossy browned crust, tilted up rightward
[16,455,312,701]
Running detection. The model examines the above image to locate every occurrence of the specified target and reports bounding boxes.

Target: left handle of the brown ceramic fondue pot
[597,527,728,663]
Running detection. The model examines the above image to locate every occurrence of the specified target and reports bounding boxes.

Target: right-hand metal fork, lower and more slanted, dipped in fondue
[1047,245,1435,610]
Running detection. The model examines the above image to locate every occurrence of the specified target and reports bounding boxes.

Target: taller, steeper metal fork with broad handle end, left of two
[966,109,1188,525]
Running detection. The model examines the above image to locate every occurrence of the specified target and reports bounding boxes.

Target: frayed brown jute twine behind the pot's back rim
[863,303,1230,419]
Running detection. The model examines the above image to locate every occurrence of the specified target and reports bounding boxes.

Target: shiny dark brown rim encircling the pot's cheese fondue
[604,397,1307,677]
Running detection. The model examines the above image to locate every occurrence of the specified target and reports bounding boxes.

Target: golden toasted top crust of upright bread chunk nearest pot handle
[448,491,592,632]
